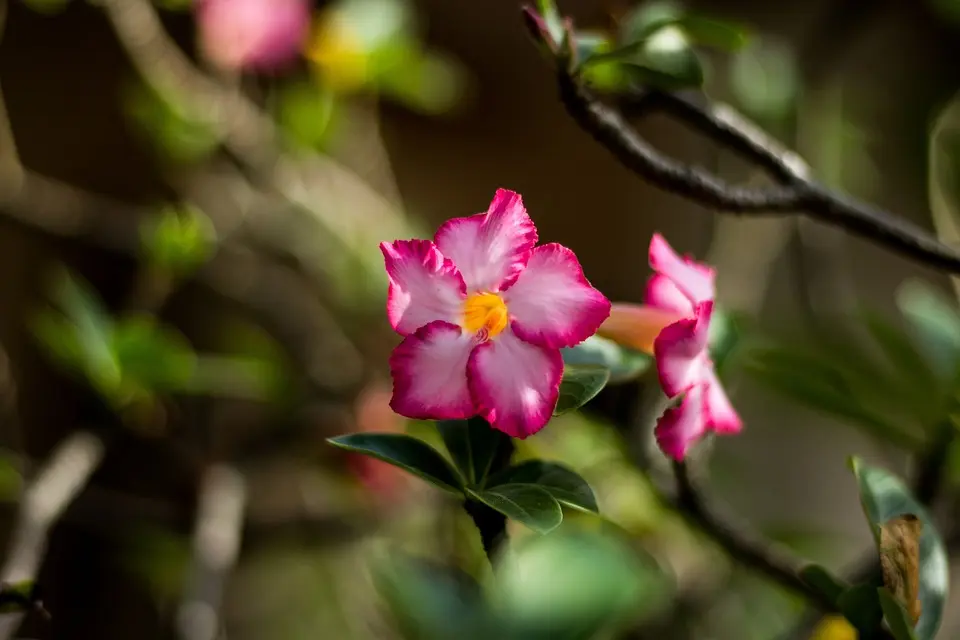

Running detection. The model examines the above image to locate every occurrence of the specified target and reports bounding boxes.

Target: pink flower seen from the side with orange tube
[598,234,743,460]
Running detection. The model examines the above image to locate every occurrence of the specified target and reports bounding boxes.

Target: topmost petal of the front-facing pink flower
[434,189,537,293]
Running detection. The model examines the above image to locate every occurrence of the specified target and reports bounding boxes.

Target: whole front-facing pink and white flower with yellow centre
[380,189,610,438]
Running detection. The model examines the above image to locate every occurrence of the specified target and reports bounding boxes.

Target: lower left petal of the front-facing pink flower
[390,321,476,420]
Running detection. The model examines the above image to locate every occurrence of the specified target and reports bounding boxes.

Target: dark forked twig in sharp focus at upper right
[557,72,960,273]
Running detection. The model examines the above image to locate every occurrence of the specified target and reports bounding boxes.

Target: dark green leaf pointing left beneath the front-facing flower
[327,433,462,493]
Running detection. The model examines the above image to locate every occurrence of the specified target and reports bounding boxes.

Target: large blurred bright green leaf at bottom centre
[491,531,671,640]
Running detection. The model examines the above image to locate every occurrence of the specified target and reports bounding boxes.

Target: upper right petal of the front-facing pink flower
[503,243,610,349]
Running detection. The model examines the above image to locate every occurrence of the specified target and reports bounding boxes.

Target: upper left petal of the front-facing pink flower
[380,240,466,336]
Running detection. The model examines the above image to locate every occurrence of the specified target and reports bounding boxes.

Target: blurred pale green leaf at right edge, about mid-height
[896,280,960,382]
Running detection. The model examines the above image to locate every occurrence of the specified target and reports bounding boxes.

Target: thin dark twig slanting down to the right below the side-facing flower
[668,463,836,611]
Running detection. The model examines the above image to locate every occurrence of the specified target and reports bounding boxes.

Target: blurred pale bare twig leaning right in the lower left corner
[0,431,104,639]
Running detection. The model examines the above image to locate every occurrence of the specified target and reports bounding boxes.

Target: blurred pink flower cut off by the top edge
[197,0,310,72]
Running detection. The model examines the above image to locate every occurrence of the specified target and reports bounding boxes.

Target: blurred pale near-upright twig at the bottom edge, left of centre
[177,465,247,640]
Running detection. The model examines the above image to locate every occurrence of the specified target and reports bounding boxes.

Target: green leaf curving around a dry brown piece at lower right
[850,458,950,640]
